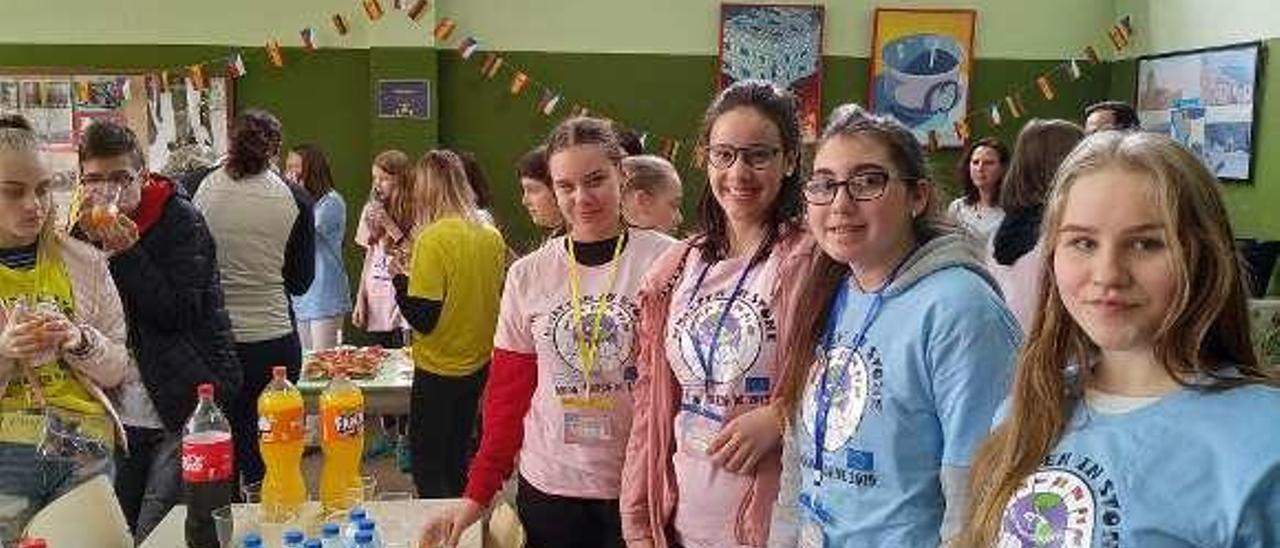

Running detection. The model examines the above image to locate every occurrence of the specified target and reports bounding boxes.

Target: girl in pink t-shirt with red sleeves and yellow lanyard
[422,118,675,547]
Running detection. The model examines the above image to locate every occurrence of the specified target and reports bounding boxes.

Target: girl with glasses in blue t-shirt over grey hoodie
[769,105,1021,547]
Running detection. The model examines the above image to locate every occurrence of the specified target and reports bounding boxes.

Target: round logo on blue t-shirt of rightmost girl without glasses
[997,469,1094,548]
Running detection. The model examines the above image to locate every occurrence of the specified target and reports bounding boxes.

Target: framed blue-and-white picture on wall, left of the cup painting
[718,4,824,141]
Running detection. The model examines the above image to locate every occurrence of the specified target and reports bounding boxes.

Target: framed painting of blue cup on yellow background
[869,9,978,149]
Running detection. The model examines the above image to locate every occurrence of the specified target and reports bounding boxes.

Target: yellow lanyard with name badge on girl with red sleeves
[561,233,626,446]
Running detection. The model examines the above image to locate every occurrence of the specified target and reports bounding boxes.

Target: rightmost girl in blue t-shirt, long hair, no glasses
[960,132,1280,548]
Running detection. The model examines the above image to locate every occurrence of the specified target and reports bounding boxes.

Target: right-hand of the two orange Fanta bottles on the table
[320,373,365,515]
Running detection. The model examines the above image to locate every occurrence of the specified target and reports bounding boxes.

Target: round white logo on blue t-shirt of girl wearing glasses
[804,346,870,451]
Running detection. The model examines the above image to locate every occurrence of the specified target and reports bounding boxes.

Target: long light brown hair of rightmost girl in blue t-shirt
[960,132,1276,547]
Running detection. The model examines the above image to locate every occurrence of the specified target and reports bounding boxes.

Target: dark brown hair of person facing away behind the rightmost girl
[1000,119,1084,211]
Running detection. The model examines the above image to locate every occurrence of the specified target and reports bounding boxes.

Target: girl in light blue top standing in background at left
[285,145,351,352]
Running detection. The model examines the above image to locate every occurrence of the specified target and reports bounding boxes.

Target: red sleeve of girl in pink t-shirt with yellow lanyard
[463,348,538,506]
